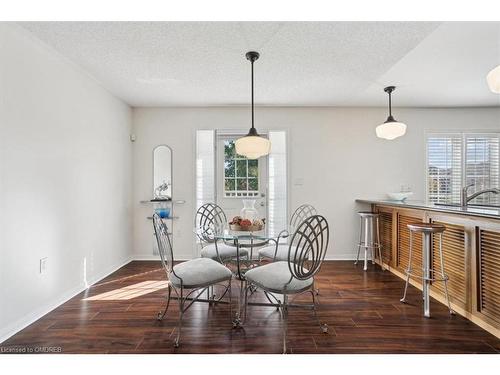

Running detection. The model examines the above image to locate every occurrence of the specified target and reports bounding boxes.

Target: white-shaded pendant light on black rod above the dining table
[236,51,271,159]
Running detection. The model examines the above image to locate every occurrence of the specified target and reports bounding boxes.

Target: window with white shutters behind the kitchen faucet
[427,133,500,206]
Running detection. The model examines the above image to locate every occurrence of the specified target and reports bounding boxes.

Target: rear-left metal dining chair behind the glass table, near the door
[194,203,248,264]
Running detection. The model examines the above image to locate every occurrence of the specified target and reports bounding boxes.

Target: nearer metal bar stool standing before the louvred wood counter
[400,223,454,318]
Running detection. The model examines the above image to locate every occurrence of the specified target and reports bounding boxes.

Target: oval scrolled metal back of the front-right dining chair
[288,215,330,280]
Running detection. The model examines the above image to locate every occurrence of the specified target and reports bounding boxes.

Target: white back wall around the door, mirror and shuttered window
[133,107,500,259]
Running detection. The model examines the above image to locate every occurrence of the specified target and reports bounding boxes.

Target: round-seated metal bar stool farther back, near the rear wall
[354,211,385,271]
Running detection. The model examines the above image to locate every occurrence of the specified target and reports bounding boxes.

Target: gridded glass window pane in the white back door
[224,140,259,198]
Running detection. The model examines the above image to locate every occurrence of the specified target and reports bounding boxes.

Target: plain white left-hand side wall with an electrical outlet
[0,23,131,342]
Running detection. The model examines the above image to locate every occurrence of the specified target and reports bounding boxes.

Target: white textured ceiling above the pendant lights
[20,22,500,106]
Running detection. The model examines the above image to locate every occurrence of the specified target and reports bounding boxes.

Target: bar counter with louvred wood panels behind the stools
[373,205,500,337]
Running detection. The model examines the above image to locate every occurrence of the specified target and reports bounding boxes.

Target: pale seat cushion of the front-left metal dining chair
[170,258,232,289]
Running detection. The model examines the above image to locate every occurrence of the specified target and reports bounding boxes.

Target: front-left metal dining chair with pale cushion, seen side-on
[153,213,233,347]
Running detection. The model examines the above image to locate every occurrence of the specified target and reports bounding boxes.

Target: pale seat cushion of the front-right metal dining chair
[245,262,313,294]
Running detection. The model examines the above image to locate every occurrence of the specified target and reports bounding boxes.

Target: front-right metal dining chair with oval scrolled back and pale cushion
[244,215,330,353]
